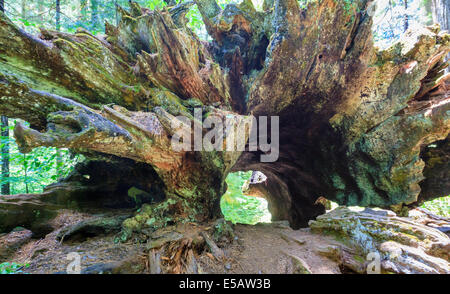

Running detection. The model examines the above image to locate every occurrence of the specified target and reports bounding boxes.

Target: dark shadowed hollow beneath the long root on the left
[46,155,166,209]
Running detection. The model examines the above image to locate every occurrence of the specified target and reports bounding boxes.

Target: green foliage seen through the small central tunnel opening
[220,171,272,225]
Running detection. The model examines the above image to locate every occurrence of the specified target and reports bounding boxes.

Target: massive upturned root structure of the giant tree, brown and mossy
[0,0,450,234]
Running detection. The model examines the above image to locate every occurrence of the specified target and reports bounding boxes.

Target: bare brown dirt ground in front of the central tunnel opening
[200,224,341,274]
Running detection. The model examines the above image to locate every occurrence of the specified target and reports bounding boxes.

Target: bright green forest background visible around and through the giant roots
[0,0,450,224]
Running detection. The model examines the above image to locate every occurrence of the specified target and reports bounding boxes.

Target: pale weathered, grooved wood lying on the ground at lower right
[310,207,450,274]
